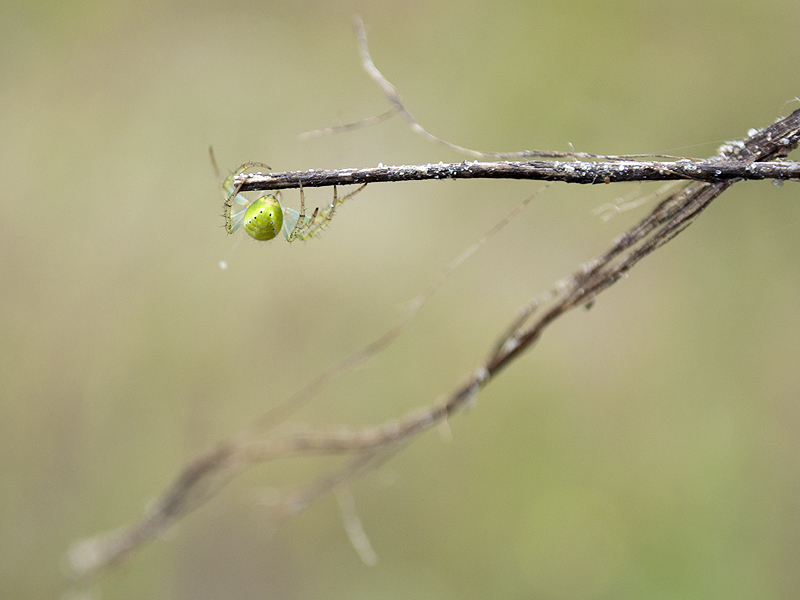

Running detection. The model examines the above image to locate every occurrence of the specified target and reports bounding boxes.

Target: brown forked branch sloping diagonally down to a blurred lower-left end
[70,14,800,578]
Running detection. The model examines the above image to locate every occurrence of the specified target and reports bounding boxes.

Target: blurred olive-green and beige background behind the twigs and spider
[0,0,800,600]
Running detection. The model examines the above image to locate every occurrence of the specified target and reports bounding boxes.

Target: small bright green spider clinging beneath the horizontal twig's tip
[211,151,367,242]
